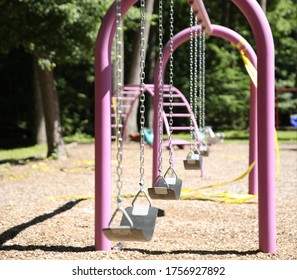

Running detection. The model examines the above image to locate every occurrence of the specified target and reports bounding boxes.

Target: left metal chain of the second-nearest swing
[158,0,164,176]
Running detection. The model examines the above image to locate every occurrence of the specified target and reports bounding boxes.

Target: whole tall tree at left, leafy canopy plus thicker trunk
[0,0,108,157]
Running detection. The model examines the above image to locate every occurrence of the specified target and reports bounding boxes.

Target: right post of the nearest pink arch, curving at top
[232,0,276,253]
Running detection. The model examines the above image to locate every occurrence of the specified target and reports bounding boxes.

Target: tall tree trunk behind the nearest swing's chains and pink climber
[125,0,154,140]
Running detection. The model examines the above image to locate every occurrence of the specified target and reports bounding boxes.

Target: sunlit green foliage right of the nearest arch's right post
[267,0,297,126]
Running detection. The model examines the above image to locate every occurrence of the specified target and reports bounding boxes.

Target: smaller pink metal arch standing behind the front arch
[153,25,258,197]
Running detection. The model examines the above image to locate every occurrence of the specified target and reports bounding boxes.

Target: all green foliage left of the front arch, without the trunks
[0,0,108,144]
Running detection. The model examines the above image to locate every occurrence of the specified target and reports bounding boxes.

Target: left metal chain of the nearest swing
[115,0,123,208]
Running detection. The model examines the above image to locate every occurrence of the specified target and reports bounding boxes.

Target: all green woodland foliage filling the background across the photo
[0,0,297,144]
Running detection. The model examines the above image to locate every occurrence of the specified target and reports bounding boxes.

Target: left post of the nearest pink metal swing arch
[95,0,137,250]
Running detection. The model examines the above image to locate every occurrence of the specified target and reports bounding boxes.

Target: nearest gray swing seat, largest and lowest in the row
[103,191,165,242]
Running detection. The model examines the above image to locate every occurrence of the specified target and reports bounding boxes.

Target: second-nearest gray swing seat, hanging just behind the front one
[148,167,182,200]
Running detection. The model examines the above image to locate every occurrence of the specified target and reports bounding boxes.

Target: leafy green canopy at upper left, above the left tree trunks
[0,0,106,66]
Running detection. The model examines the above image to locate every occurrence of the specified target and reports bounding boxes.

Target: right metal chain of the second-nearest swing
[169,0,174,168]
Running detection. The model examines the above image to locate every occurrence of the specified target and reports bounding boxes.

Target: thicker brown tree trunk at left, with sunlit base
[38,64,67,158]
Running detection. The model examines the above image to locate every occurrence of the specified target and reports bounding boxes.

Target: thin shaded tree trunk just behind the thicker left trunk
[33,58,46,145]
